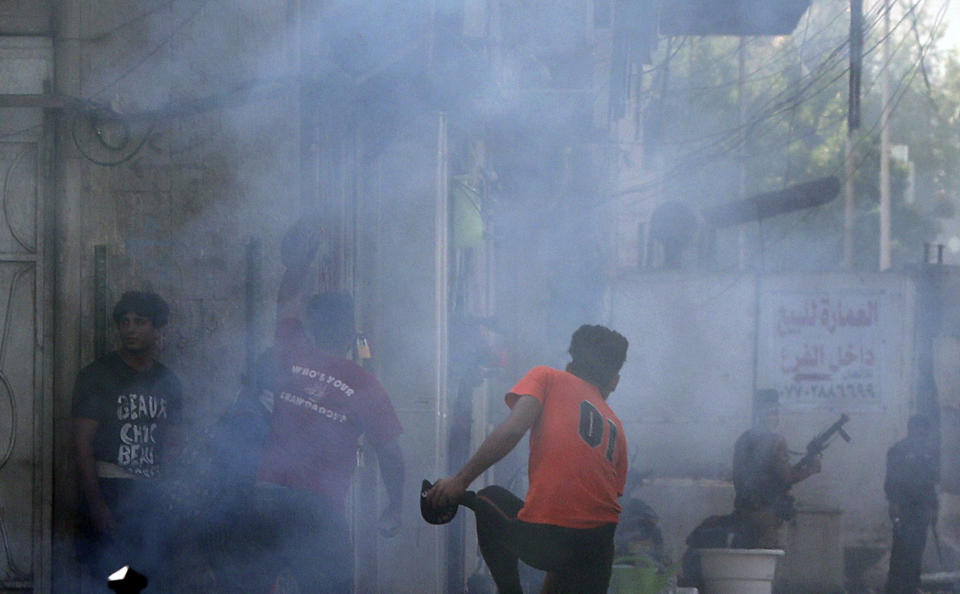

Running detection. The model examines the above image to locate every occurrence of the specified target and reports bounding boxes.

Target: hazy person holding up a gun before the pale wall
[733,390,820,549]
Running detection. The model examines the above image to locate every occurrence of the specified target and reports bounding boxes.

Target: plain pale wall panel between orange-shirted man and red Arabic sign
[610,273,756,478]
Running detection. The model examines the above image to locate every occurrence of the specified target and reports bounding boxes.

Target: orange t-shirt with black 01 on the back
[505,367,627,528]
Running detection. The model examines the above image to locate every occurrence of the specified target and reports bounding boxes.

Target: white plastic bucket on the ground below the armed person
[698,549,783,594]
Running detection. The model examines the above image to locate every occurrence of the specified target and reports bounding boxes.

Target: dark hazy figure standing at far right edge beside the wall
[883,415,940,594]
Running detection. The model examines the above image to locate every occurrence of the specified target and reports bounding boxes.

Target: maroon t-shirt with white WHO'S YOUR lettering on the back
[257,318,402,507]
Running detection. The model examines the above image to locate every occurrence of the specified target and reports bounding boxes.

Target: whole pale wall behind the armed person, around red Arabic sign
[610,272,915,553]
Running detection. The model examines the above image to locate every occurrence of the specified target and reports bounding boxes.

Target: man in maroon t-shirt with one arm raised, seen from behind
[254,219,404,593]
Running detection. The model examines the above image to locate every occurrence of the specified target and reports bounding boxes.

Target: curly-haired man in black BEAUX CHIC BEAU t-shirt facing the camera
[71,291,182,583]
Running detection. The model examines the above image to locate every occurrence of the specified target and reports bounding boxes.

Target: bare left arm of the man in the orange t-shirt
[427,395,542,507]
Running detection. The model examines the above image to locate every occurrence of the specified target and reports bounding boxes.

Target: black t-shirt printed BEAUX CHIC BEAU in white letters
[72,352,183,478]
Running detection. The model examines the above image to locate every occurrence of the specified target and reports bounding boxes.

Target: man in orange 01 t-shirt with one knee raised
[423,325,628,594]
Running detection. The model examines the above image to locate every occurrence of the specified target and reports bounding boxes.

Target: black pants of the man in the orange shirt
[470,485,617,594]
